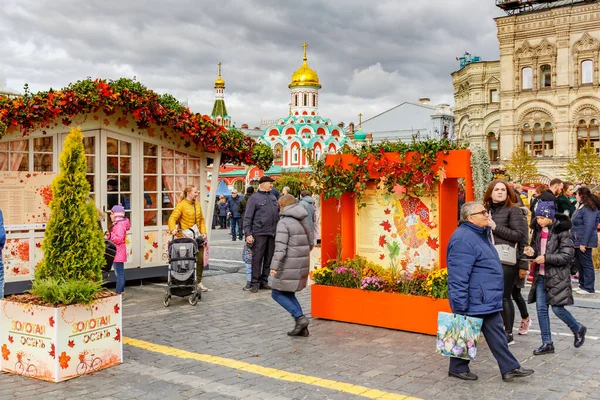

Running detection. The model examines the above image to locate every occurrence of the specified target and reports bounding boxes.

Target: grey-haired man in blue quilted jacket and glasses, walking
[446,201,533,382]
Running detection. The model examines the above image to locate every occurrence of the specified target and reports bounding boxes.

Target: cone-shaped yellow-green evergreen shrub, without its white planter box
[31,129,105,304]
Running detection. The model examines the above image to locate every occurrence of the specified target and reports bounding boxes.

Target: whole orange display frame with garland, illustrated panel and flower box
[311,140,473,334]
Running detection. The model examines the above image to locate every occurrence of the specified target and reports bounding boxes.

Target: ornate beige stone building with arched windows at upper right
[452,2,600,177]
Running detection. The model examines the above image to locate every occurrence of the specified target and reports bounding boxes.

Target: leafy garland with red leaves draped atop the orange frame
[311,139,465,208]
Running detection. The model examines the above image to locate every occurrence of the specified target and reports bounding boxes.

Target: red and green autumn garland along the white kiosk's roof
[0,78,273,169]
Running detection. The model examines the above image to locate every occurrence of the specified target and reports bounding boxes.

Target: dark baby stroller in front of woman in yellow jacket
[163,237,204,307]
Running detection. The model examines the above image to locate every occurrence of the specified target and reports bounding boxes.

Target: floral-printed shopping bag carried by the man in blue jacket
[435,312,483,360]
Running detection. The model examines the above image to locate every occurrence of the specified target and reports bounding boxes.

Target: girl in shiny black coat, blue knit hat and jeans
[525,201,587,356]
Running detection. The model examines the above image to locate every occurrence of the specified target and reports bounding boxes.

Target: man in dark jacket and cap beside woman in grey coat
[244,176,279,293]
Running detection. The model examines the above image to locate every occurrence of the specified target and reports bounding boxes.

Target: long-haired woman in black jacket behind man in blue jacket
[483,179,529,344]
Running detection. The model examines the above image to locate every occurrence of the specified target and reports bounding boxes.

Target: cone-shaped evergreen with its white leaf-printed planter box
[0,129,123,382]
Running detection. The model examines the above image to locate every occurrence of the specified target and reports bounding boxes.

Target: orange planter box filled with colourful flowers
[311,257,450,335]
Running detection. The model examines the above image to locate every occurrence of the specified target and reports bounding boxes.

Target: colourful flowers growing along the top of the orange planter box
[311,256,448,299]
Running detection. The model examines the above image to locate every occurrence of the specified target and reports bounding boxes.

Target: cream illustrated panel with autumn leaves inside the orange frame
[356,184,439,272]
